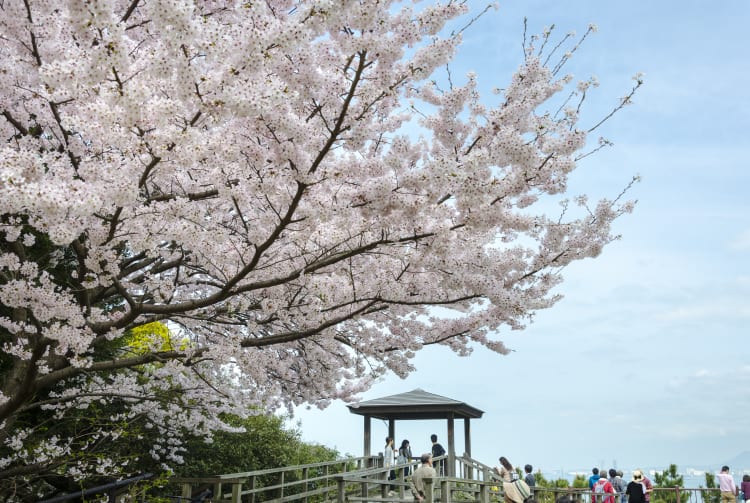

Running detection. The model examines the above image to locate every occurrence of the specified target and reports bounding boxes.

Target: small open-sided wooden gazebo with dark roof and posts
[348,388,484,476]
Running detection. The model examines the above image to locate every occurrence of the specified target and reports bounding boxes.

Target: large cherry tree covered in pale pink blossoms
[0,0,640,496]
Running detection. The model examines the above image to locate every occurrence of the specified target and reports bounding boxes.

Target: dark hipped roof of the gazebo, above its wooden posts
[348,388,484,419]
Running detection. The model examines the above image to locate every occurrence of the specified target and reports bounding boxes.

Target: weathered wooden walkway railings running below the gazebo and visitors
[173,456,719,503]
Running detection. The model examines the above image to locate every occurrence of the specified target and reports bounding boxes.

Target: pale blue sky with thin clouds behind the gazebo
[295,0,750,471]
